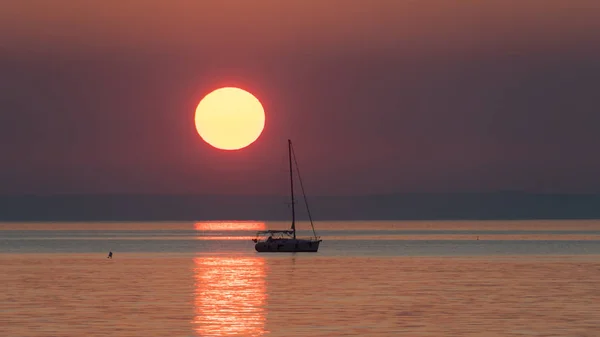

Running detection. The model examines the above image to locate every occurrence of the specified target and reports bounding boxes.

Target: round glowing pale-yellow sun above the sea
[195,87,265,150]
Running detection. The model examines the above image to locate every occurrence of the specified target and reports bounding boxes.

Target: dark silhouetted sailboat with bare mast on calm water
[252,139,323,253]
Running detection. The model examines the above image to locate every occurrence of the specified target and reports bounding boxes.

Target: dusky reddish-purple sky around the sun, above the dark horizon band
[0,0,600,195]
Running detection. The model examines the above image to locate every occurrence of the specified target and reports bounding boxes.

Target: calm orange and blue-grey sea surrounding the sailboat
[0,220,600,337]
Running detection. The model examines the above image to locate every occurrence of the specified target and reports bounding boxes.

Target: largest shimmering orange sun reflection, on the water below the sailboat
[193,257,267,336]
